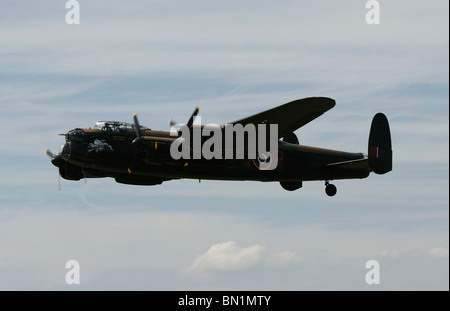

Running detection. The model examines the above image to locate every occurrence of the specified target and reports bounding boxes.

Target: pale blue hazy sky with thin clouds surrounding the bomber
[0,0,449,290]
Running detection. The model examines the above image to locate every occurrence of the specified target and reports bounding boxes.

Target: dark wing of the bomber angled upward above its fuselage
[228,97,336,138]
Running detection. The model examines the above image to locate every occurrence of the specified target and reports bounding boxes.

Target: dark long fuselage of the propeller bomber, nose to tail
[54,129,370,184]
